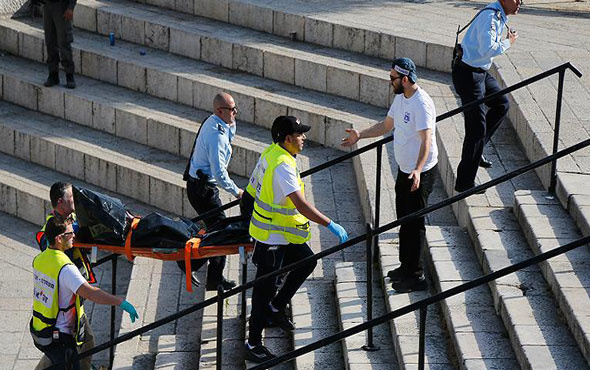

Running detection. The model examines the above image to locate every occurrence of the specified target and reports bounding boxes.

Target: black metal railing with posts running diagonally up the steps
[49,62,590,369]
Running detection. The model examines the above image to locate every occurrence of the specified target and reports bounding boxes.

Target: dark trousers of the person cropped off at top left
[43,0,74,74]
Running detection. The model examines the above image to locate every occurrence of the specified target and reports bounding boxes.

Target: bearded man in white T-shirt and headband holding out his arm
[342,58,438,293]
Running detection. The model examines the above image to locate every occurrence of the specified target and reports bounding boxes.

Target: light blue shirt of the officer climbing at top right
[461,2,510,71]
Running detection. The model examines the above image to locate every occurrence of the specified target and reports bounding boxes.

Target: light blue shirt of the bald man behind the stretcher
[189,114,240,196]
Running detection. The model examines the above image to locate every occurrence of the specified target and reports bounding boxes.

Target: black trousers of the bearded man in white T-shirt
[395,166,436,275]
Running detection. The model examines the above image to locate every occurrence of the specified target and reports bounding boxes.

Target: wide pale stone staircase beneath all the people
[0,0,590,369]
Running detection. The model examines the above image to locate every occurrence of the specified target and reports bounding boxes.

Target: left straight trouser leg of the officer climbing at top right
[453,68,486,191]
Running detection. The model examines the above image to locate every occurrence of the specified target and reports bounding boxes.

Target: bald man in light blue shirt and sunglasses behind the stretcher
[178,93,243,290]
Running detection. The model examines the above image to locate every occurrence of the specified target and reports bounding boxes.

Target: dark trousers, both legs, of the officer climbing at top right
[453,64,509,189]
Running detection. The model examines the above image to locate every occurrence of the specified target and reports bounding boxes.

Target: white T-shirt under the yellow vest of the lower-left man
[55,264,86,334]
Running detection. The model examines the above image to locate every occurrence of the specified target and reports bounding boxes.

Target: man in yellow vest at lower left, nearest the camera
[29,217,139,370]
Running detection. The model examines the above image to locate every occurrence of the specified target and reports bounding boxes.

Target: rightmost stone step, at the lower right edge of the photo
[514,190,590,368]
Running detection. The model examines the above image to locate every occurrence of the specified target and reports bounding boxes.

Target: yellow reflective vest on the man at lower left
[29,248,85,349]
